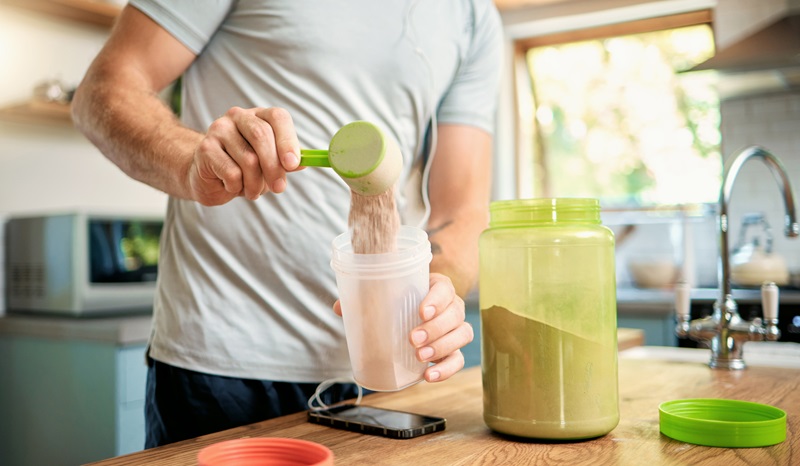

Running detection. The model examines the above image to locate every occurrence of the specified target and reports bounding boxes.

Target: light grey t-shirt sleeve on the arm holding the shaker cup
[437,1,503,134]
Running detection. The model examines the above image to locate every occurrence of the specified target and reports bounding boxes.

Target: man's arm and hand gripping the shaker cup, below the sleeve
[410,125,492,382]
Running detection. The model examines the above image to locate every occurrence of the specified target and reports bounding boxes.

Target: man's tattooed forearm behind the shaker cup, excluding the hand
[428,125,492,297]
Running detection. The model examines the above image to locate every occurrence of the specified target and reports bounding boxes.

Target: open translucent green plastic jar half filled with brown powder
[479,198,619,440]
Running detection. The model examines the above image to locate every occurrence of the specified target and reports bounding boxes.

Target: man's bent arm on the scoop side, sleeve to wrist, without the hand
[72,6,203,198]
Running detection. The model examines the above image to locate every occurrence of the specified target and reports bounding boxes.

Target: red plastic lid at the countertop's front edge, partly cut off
[197,437,333,466]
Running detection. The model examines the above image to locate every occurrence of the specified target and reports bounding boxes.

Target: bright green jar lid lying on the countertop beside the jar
[658,398,786,448]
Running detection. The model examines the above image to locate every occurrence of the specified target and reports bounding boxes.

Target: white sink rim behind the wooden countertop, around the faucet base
[619,341,800,369]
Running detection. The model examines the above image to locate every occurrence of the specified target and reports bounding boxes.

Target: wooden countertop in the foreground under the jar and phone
[84,350,800,466]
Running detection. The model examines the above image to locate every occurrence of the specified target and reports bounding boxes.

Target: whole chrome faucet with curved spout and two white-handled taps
[675,146,800,370]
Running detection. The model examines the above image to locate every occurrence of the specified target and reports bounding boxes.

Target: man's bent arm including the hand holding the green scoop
[72,6,300,205]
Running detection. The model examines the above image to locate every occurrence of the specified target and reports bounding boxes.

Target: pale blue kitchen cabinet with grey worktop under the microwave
[0,315,150,466]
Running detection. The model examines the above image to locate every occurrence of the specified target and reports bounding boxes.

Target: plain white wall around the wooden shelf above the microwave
[0,3,166,214]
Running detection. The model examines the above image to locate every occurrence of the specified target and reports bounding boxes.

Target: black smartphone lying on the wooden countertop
[308,404,446,439]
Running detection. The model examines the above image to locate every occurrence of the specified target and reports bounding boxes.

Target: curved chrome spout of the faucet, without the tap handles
[718,146,800,296]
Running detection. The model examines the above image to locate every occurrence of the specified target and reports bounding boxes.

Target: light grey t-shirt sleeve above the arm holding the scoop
[129,0,236,54]
